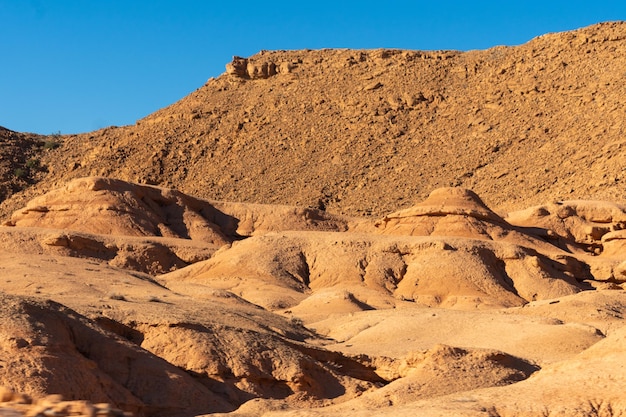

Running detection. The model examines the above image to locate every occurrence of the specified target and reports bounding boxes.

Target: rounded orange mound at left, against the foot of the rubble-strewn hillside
[10,178,236,245]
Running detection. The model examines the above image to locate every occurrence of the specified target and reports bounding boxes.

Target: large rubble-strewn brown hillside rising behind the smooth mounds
[1,22,626,216]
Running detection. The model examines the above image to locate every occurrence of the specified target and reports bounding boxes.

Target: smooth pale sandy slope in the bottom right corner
[256,329,626,417]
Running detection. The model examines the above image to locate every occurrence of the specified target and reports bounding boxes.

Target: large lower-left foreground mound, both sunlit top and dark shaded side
[0,250,386,416]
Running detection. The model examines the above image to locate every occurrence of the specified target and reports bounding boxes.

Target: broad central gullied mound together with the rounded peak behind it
[163,188,591,311]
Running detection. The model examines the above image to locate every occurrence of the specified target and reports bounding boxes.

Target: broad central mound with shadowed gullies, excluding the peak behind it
[162,232,580,310]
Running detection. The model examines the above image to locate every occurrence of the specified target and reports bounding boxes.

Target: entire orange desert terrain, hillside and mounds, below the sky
[0,22,626,417]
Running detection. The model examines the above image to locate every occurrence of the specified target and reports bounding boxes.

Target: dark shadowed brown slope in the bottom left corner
[0,295,230,416]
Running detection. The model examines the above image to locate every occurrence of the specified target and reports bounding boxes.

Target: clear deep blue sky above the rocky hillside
[0,0,626,134]
